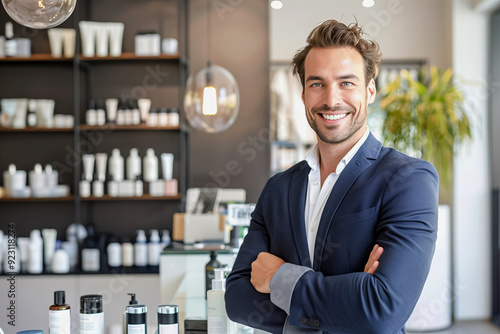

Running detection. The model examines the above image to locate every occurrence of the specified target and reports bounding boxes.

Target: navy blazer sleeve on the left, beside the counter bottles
[225,180,287,333]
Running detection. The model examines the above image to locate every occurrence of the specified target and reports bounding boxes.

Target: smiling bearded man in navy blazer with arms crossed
[226,20,439,334]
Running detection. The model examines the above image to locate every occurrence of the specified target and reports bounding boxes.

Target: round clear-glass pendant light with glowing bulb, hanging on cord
[184,0,239,133]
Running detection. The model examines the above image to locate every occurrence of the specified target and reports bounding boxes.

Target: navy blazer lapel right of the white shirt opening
[313,133,382,271]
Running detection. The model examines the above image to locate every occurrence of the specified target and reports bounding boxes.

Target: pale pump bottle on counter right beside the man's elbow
[207,268,229,334]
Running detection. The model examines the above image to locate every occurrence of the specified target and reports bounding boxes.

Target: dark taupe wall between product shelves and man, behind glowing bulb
[188,0,270,202]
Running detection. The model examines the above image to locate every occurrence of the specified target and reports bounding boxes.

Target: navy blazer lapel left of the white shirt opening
[288,162,312,268]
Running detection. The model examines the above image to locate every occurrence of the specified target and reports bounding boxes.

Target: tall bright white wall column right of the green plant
[453,0,491,319]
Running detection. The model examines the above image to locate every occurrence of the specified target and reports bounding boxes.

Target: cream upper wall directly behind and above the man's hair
[270,0,451,67]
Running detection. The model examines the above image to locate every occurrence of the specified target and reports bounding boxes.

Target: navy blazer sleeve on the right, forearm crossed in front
[290,160,439,334]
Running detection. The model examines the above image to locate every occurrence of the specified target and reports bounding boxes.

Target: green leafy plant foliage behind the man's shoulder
[380,66,471,186]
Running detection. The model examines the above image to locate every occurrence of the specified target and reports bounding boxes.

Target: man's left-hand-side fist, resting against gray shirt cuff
[250,252,285,293]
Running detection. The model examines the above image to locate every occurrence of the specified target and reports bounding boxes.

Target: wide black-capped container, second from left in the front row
[80,295,104,334]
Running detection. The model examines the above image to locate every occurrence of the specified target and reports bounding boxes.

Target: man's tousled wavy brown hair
[292,20,382,88]
